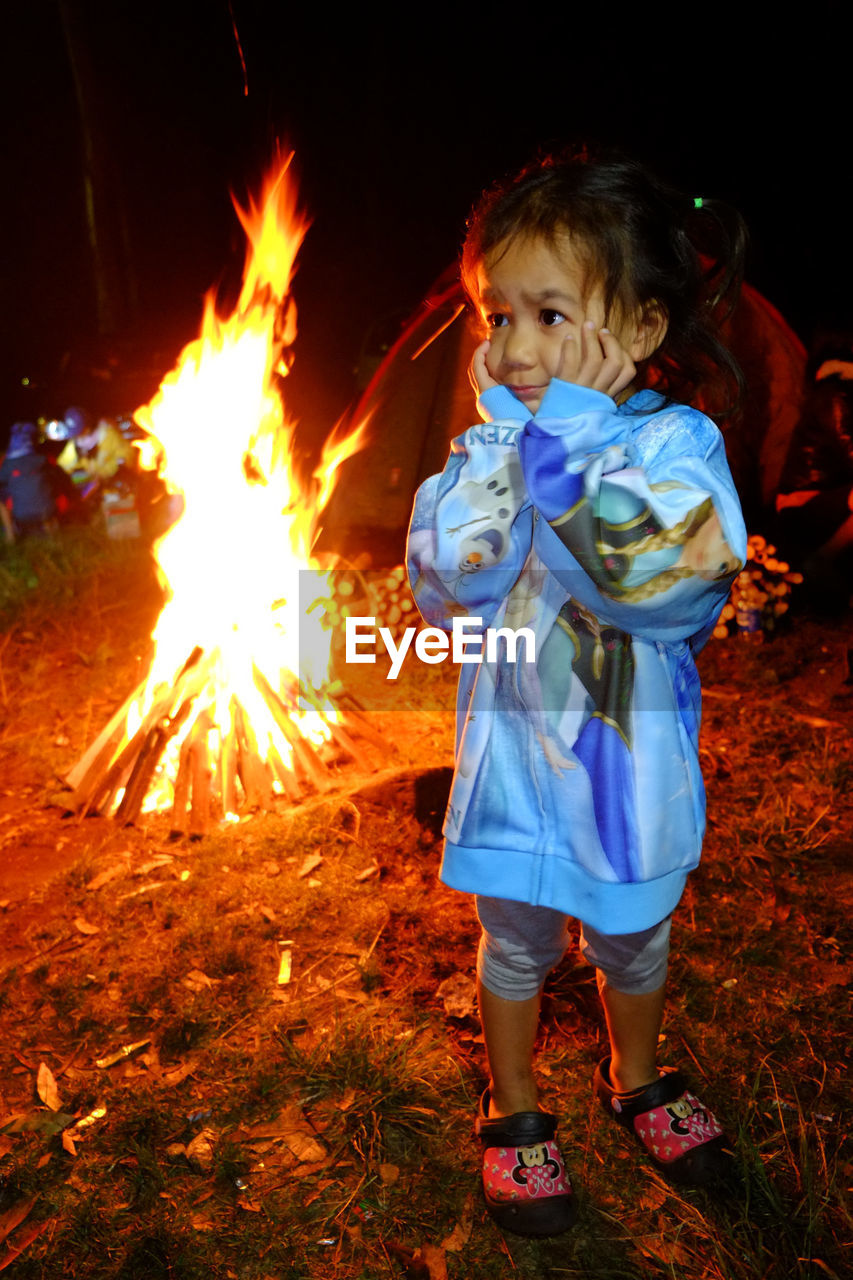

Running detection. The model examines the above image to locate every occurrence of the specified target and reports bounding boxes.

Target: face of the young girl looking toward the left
[476,236,649,413]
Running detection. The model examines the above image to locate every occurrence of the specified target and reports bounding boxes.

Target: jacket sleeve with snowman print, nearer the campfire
[407,419,533,630]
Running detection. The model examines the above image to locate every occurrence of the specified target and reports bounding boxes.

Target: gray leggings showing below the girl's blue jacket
[476,897,671,1000]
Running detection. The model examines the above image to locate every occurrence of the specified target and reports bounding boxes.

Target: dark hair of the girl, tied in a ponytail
[461,148,747,416]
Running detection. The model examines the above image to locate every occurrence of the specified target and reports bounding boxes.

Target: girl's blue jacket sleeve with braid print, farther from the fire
[520,379,747,643]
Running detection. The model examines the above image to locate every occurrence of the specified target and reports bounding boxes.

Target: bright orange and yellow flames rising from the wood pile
[117,157,364,815]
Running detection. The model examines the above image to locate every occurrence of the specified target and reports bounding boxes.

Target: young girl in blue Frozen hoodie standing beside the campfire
[409,156,745,1235]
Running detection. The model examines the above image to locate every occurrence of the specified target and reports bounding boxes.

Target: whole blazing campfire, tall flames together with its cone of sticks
[67,159,371,836]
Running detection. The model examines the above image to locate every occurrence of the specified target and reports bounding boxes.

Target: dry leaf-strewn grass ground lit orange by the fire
[0,535,853,1280]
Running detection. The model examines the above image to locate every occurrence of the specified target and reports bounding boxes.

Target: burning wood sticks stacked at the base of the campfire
[65,648,386,838]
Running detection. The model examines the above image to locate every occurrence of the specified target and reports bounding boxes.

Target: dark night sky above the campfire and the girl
[0,0,853,440]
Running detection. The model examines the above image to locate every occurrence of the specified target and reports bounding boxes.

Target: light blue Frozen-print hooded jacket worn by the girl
[407,379,747,933]
